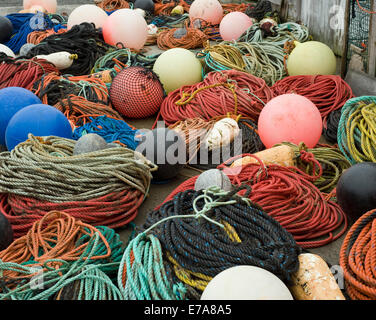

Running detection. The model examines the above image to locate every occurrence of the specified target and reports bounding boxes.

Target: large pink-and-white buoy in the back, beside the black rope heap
[103,9,148,50]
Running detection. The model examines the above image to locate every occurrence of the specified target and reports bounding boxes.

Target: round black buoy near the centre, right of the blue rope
[136,128,186,181]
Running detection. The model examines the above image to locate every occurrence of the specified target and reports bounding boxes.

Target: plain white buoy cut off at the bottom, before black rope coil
[201,266,294,300]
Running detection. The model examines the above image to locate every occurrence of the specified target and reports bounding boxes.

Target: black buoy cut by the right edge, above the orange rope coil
[337,162,376,224]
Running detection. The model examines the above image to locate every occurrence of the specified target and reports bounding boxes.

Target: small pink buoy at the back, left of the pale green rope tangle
[219,12,253,41]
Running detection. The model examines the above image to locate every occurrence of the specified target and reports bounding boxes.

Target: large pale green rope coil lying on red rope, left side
[0,134,156,237]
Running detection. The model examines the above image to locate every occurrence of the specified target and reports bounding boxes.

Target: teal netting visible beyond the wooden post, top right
[347,0,373,73]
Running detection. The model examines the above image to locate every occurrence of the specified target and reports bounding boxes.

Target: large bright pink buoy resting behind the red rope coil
[258,94,323,148]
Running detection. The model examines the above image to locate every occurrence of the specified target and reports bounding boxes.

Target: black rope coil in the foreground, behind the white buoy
[143,186,301,281]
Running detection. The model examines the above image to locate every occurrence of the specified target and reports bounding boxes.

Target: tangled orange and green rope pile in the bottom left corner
[0,211,123,300]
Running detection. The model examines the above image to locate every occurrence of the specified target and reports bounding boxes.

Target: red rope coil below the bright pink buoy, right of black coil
[165,156,347,249]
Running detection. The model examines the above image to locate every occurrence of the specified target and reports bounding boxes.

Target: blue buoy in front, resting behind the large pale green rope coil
[5,104,72,151]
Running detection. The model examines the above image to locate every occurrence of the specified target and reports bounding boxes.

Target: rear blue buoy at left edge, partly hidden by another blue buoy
[0,87,42,146]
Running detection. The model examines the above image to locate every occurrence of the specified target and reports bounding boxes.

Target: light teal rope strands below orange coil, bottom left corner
[0,232,122,300]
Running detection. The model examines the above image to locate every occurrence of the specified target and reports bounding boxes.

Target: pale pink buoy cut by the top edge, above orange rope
[189,0,223,25]
